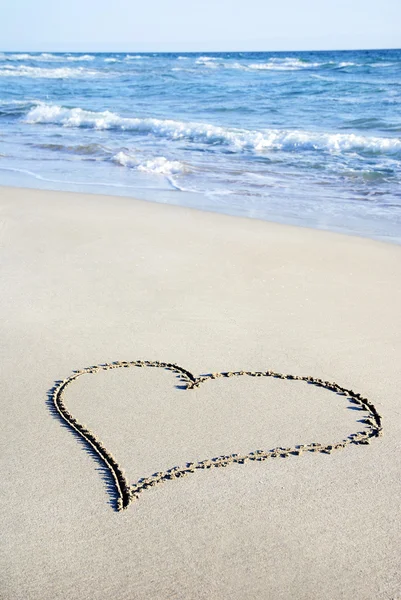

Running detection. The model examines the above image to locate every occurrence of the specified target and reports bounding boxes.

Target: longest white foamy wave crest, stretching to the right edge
[25,104,401,154]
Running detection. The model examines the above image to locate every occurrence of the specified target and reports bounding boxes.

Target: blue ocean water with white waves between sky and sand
[0,50,401,243]
